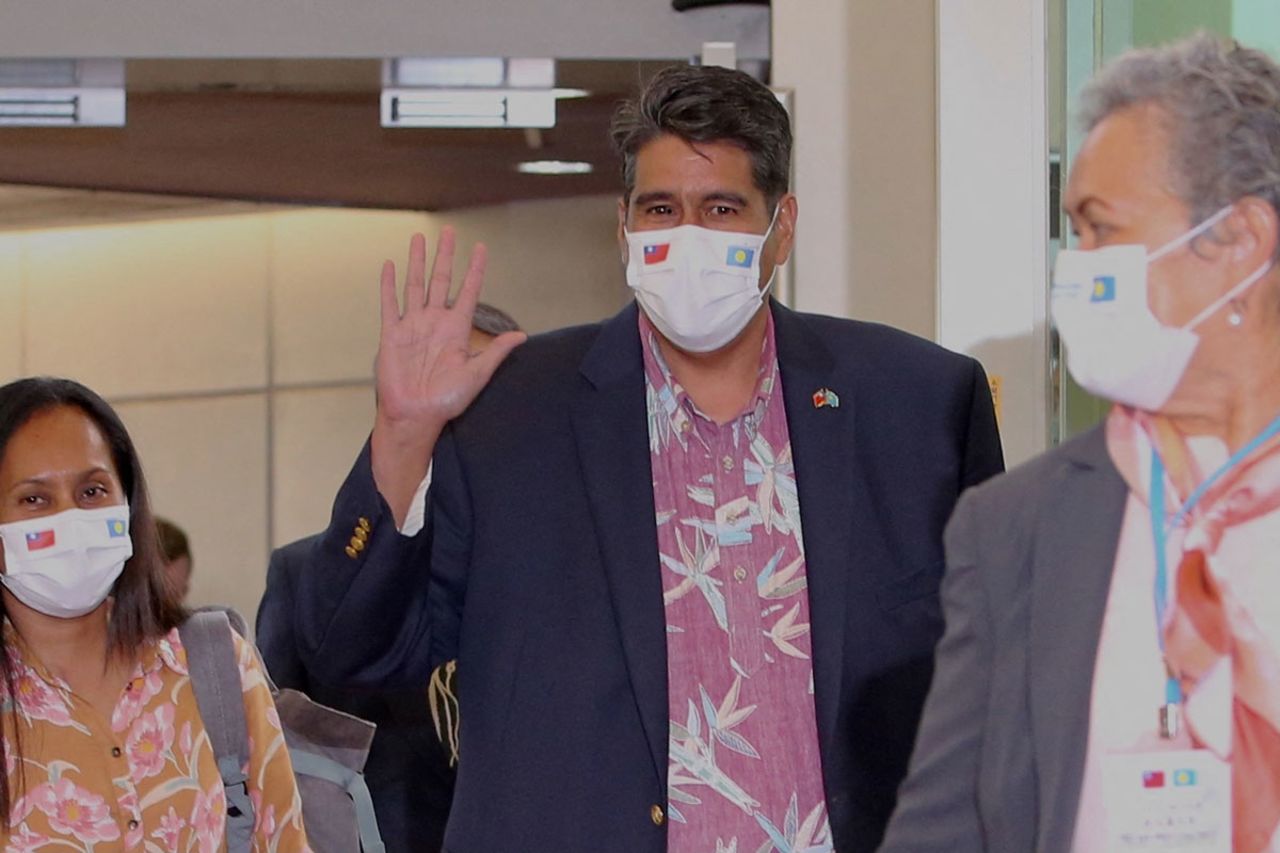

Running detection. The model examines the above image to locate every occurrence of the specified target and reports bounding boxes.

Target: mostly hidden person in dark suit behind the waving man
[255,302,520,853]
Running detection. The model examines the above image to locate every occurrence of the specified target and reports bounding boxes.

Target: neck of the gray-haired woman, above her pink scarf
[1162,329,1280,453]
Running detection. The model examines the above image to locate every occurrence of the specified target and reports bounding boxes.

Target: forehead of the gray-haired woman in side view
[1062,104,1175,210]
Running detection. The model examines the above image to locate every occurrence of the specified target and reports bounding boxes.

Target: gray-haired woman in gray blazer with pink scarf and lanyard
[881,35,1280,853]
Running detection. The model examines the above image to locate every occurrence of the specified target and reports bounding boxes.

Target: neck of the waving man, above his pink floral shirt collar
[658,302,769,424]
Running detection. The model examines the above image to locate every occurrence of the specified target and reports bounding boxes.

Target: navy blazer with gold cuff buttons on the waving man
[298,304,1004,853]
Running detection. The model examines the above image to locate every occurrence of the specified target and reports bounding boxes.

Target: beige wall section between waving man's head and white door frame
[773,0,937,338]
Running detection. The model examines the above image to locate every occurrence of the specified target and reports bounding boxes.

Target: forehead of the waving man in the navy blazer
[635,134,759,193]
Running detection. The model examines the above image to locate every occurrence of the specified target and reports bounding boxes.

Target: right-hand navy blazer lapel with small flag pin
[772,302,856,756]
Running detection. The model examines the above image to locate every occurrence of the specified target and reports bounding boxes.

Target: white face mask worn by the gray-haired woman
[1052,205,1271,411]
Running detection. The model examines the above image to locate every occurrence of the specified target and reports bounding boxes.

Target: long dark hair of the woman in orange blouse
[0,377,186,827]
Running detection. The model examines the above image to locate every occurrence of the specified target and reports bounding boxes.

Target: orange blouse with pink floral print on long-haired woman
[0,622,308,853]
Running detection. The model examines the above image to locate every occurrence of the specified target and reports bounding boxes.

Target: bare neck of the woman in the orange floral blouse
[4,589,111,684]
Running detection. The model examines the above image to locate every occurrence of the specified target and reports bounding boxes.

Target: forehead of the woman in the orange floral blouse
[0,406,116,484]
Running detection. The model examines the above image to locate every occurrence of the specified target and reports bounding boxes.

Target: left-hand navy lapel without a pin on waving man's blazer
[572,304,668,790]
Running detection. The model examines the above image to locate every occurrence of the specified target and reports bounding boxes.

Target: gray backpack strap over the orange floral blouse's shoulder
[178,610,255,853]
